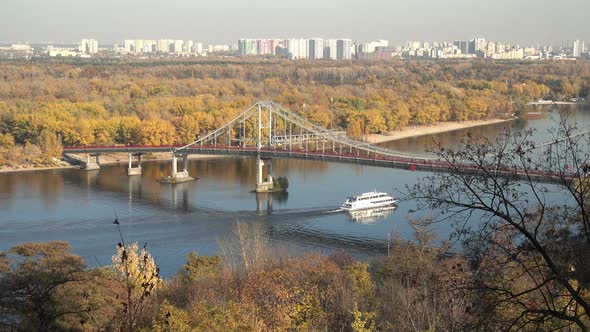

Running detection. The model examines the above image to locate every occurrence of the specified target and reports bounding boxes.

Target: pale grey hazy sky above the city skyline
[0,0,590,44]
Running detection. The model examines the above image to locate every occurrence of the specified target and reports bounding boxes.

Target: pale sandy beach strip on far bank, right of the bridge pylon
[365,118,516,144]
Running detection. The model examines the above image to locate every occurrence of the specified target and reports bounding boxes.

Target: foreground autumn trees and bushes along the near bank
[0,222,572,332]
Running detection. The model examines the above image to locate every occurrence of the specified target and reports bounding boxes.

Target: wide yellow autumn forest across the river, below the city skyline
[0,60,590,166]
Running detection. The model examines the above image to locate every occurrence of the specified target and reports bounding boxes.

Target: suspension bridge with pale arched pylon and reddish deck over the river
[63,101,572,192]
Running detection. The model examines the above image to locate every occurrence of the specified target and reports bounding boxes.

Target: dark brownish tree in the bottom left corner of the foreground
[0,241,88,331]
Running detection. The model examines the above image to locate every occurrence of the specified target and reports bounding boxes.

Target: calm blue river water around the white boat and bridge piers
[0,108,590,276]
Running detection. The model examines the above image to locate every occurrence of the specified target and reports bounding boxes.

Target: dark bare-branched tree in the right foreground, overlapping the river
[411,119,590,330]
